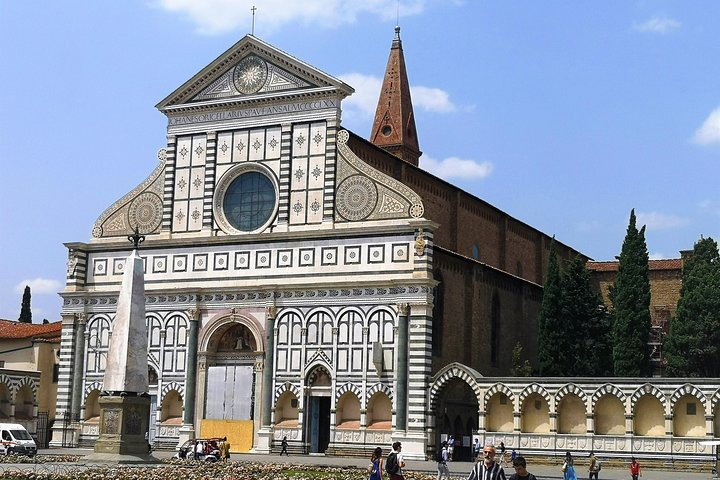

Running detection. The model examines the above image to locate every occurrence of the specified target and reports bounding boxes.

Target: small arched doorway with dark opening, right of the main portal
[305,365,333,453]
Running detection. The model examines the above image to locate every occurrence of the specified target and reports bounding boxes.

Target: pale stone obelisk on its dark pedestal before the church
[87,230,155,463]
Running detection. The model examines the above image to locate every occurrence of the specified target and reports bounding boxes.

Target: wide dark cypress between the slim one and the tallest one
[562,256,612,377]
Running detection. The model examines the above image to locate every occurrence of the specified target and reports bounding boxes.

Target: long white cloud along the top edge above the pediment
[157,0,427,37]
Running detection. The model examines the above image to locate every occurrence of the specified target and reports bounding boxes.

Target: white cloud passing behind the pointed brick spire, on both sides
[339,73,455,118]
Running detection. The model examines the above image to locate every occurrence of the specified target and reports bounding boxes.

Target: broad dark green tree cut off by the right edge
[664,234,720,377]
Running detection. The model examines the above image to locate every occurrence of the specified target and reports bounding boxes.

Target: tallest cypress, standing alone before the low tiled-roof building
[610,210,652,377]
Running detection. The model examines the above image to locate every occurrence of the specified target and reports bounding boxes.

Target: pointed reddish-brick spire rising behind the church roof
[370,27,422,166]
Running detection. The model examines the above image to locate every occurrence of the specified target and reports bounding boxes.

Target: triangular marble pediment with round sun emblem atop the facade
[157,35,353,110]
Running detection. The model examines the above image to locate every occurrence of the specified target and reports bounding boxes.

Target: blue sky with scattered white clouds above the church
[0,0,720,322]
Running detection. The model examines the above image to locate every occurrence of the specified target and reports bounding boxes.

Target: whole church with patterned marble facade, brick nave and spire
[53,30,714,458]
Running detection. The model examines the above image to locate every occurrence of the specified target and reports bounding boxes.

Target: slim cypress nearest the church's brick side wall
[538,241,575,377]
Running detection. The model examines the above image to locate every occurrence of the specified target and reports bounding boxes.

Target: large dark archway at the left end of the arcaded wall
[435,378,479,462]
